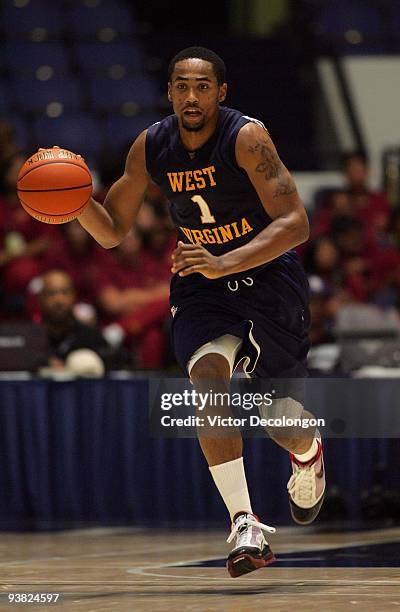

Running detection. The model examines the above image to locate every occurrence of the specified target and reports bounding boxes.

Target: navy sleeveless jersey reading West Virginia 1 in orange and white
[146,107,278,268]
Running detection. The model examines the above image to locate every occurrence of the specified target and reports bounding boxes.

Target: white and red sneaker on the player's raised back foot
[287,438,325,525]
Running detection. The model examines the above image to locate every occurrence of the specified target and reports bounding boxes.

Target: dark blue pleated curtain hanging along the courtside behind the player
[0,379,400,530]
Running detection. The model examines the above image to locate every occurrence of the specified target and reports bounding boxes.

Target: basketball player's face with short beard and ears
[168,58,227,132]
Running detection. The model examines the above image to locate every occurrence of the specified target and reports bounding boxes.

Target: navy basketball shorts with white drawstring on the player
[170,251,310,379]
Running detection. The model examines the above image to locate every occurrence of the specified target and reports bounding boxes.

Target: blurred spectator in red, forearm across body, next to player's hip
[98,229,170,369]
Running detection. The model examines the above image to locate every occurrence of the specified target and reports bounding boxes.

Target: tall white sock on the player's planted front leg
[210,457,252,519]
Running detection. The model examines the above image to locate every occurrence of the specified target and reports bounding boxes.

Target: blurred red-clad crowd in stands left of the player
[0,118,175,369]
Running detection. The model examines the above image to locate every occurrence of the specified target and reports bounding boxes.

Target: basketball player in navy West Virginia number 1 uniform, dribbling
[79,47,325,577]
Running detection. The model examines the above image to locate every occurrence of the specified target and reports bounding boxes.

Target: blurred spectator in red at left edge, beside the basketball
[0,153,57,317]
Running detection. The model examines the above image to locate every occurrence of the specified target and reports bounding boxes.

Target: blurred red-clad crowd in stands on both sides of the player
[0,117,400,369]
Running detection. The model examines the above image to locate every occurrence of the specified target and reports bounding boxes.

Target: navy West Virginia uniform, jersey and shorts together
[146,107,309,377]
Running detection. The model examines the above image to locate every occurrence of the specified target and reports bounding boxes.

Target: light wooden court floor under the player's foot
[0,528,400,612]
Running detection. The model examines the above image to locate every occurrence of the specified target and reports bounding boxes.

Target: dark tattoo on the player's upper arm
[248,139,296,198]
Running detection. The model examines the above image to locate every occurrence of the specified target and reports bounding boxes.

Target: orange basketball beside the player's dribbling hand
[17,147,93,223]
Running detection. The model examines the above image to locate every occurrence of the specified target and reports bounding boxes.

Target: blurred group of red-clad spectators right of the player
[301,152,400,346]
